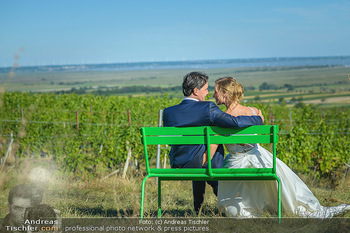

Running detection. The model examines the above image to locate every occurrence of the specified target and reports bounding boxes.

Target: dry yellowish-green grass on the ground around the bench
[0,158,350,218]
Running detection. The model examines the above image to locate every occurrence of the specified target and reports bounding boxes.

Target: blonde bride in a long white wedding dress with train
[211,77,350,218]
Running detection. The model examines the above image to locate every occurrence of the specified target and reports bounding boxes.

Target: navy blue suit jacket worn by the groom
[163,99,263,168]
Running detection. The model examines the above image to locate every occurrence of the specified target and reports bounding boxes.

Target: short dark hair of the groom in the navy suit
[182,72,209,96]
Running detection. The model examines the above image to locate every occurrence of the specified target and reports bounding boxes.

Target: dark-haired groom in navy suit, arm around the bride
[163,72,263,214]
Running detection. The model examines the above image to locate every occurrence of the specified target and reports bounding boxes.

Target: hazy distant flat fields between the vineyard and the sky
[0,64,350,104]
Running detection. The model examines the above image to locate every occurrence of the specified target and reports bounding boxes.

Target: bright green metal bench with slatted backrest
[140,125,281,220]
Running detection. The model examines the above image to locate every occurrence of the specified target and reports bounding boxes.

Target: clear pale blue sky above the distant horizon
[0,0,350,67]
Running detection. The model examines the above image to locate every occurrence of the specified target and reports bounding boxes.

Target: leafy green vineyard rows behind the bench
[0,92,350,178]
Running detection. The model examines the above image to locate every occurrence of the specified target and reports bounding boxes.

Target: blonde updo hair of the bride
[215,77,244,103]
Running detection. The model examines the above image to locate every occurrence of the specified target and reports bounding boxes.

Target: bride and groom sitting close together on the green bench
[163,72,350,218]
